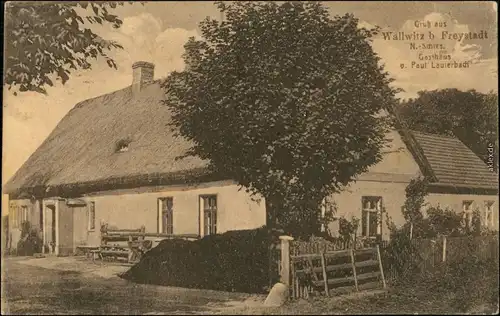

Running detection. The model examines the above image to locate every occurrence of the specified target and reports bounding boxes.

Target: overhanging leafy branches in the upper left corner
[4,1,133,93]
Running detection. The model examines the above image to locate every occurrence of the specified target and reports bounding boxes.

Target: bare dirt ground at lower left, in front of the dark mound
[2,258,263,315]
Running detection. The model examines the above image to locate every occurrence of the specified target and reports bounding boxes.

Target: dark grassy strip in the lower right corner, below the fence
[224,257,498,315]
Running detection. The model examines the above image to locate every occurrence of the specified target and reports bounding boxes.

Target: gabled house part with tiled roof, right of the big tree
[330,127,498,239]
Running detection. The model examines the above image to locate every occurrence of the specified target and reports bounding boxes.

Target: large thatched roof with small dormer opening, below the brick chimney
[4,82,207,198]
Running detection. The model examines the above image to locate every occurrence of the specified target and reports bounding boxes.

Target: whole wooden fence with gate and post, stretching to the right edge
[269,235,499,297]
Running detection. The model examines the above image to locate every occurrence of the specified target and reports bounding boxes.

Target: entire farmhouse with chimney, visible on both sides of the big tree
[4,62,498,254]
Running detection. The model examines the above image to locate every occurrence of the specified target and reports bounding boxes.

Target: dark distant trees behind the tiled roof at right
[400,89,498,167]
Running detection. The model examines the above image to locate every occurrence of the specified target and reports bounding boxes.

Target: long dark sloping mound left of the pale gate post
[122,228,278,293]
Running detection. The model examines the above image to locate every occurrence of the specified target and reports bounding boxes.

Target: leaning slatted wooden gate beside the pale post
[270,236,385,298]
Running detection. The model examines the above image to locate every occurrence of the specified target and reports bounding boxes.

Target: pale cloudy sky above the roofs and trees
[2,1,498,190]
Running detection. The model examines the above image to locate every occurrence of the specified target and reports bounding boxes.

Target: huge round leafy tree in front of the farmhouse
[163,2,397,237]
